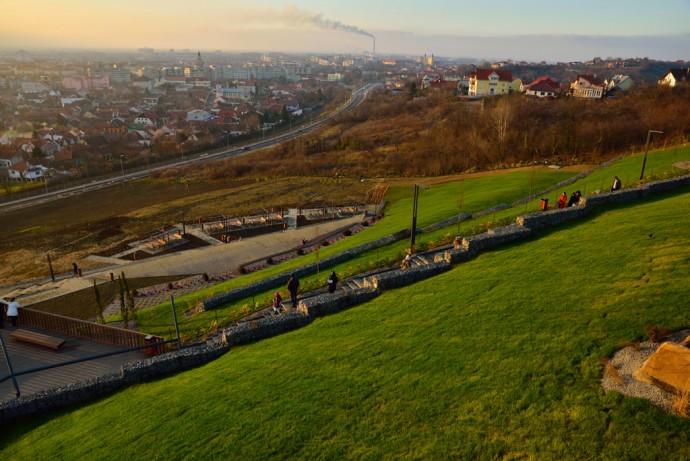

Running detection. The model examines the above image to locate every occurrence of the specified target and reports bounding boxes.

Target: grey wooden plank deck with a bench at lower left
[0,321,147,402]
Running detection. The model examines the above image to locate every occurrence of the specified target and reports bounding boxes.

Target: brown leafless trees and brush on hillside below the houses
[157,86,690,180]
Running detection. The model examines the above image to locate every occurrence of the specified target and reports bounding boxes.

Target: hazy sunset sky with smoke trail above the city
[0,0,690,62]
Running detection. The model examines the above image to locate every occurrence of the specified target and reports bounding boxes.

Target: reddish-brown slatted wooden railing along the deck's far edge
[18,307,164,355]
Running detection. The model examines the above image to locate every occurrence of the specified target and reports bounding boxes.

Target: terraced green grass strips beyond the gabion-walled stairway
[134,147,690,336]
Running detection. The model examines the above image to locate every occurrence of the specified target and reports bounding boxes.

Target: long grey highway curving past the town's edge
[0,83,378,214]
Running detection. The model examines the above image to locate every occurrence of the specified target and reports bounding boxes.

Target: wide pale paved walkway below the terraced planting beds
[2,215,362,306]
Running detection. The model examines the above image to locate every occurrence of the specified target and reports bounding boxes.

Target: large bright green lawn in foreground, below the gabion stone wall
[0,183,690,460]
